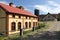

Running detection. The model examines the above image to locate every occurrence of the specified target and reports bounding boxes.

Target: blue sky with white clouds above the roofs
[0,0,60,14]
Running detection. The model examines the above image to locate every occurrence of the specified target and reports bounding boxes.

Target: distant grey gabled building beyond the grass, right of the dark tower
[39,13,57,21]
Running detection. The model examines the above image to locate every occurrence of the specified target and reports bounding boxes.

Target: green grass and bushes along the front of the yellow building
[0,22,46,40]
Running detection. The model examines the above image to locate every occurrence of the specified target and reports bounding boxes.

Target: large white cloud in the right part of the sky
[34,1,60,13]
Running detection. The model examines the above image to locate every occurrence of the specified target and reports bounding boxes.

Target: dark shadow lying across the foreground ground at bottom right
[25,31,60,40]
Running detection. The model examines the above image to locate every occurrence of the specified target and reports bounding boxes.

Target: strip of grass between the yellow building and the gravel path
[0,22,49,40]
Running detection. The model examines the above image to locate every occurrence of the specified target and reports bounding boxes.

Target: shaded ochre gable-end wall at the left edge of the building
[0,8,6,33]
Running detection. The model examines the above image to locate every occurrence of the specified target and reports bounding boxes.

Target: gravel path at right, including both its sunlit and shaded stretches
[26,22,60,40]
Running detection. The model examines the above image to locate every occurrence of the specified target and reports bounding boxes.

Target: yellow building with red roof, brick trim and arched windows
[0,3,38,35]
